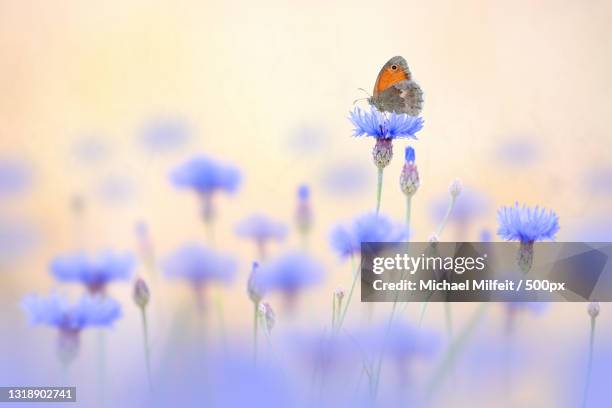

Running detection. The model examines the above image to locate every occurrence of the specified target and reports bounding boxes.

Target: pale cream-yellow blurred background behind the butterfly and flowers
[0,0,612,406]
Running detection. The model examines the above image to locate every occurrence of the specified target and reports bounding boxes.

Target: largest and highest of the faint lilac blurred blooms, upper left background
[139,118,191,153]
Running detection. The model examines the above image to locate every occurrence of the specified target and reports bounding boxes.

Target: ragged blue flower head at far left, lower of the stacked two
[22,293,121,331]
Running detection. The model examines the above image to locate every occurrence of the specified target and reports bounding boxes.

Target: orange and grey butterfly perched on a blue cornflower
[368,56,423,116]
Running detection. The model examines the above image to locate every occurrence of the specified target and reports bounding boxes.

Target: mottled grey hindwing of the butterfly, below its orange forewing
[369,80,423,116]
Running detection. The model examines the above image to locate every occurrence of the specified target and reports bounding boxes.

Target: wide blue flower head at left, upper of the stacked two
[51,250,135,293]
